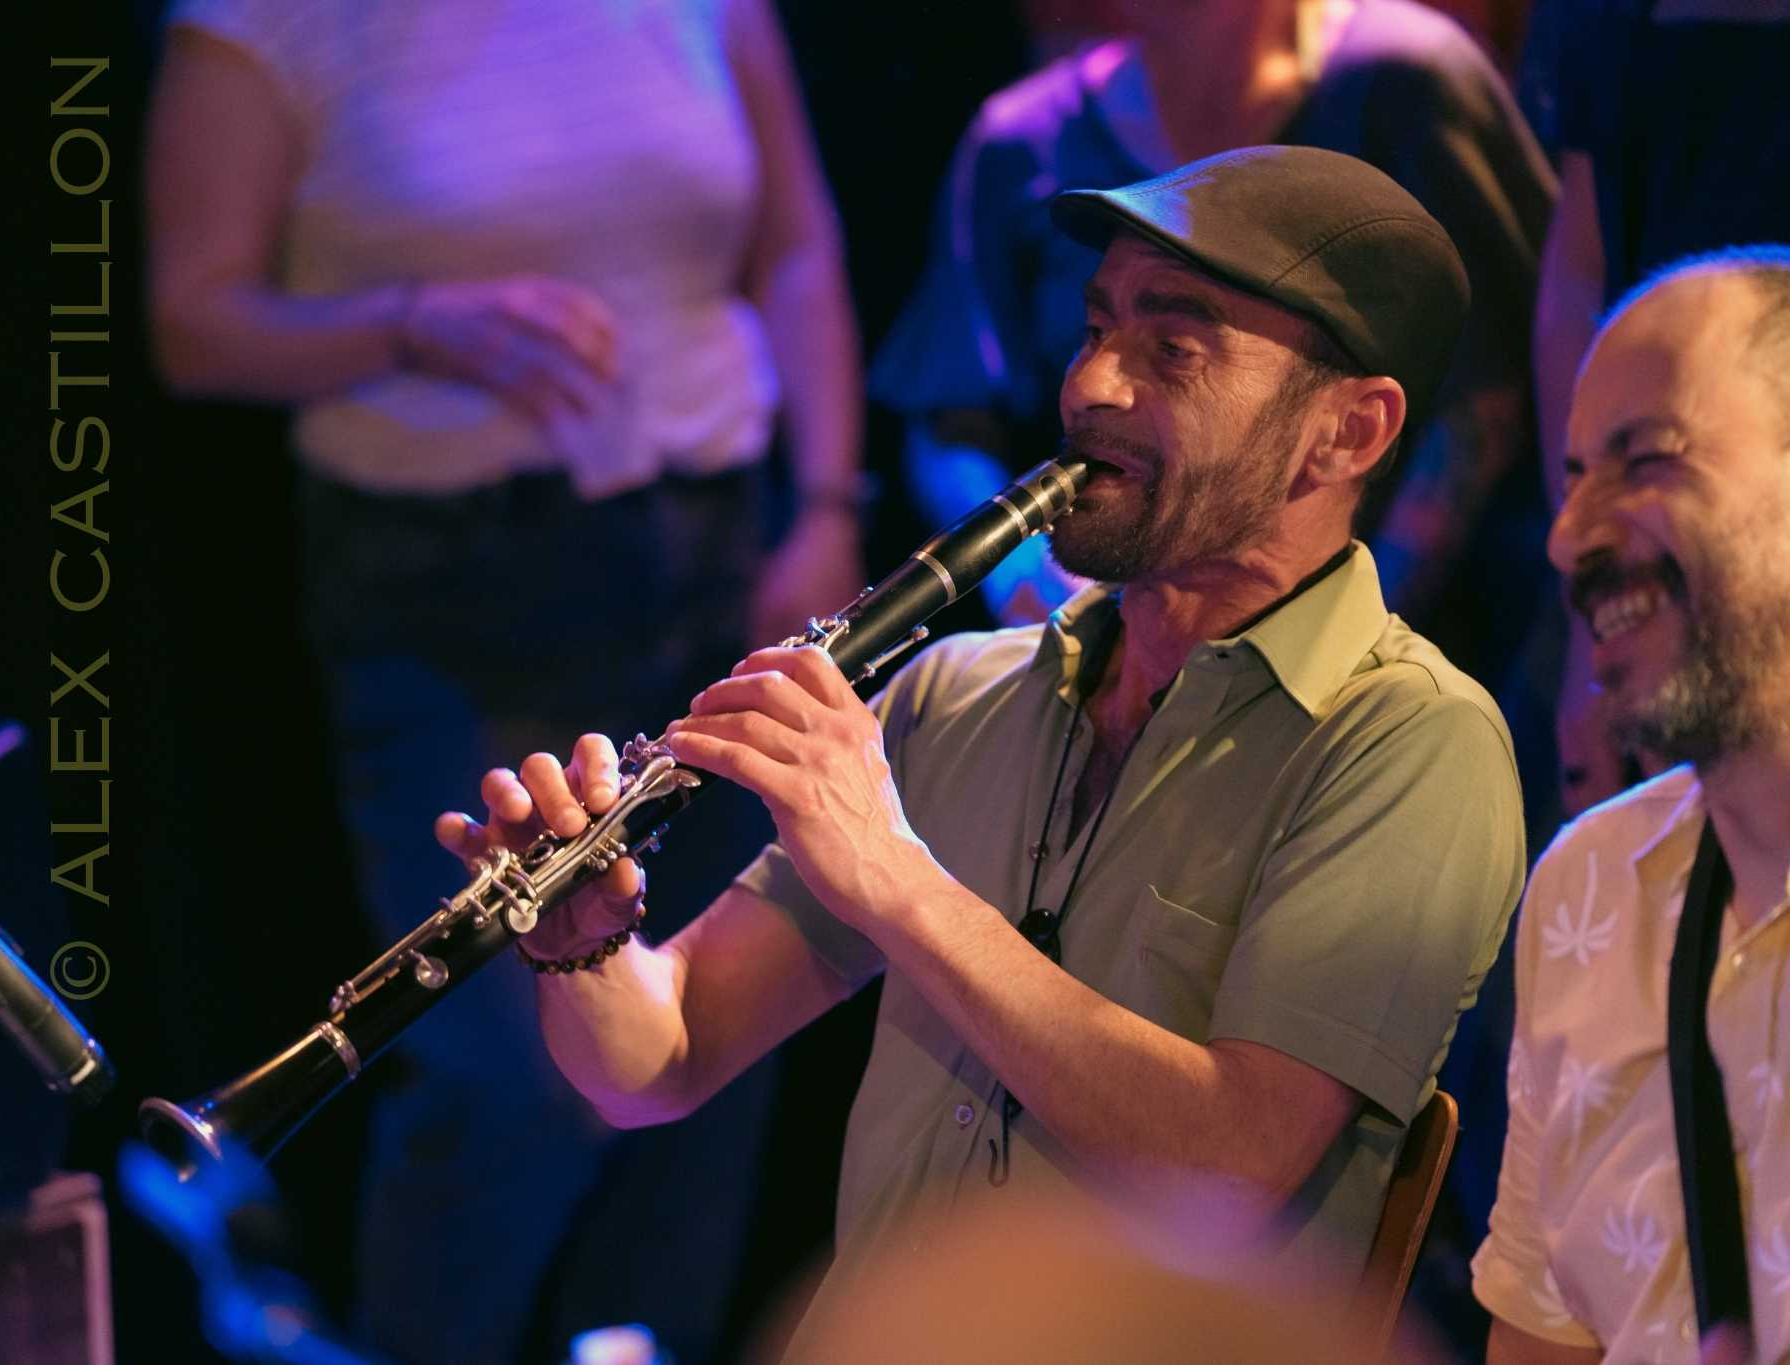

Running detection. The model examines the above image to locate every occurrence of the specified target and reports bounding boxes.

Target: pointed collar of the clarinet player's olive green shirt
[1038,540,1389,716]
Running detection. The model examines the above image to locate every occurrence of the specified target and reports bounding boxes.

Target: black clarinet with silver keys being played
[140,456,1088,1174]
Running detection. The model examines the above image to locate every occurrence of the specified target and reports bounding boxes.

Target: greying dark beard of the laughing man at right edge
[1572,558,1772,766]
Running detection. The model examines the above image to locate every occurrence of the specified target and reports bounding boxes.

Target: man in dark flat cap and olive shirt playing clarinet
[437,147,1523,1323]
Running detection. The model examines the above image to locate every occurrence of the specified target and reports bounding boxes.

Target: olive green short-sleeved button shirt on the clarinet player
[739,544,1523,1274]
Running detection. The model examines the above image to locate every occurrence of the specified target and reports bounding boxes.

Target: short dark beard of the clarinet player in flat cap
[1051,394,1307,583]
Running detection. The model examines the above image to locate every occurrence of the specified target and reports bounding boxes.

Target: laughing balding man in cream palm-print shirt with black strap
[1473,247,1790,1365]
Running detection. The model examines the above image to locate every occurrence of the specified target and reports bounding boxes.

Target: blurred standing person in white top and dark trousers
[147,0,863,1363]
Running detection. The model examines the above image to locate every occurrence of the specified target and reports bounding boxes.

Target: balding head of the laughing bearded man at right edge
[1548,247,1790,764]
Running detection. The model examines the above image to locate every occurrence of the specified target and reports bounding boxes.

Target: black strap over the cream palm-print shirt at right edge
[1666,821,1751,1335]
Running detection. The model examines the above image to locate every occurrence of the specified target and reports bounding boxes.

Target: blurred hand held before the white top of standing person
[397,276,616,428]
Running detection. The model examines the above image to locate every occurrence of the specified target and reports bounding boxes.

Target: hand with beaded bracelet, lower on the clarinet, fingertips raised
[435,735,646,959]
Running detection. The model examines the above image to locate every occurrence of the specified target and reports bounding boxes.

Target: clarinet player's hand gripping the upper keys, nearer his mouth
[666,648,945,937]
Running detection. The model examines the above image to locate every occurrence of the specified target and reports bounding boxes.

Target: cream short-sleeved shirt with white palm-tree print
[1473,767,1790,1365]
